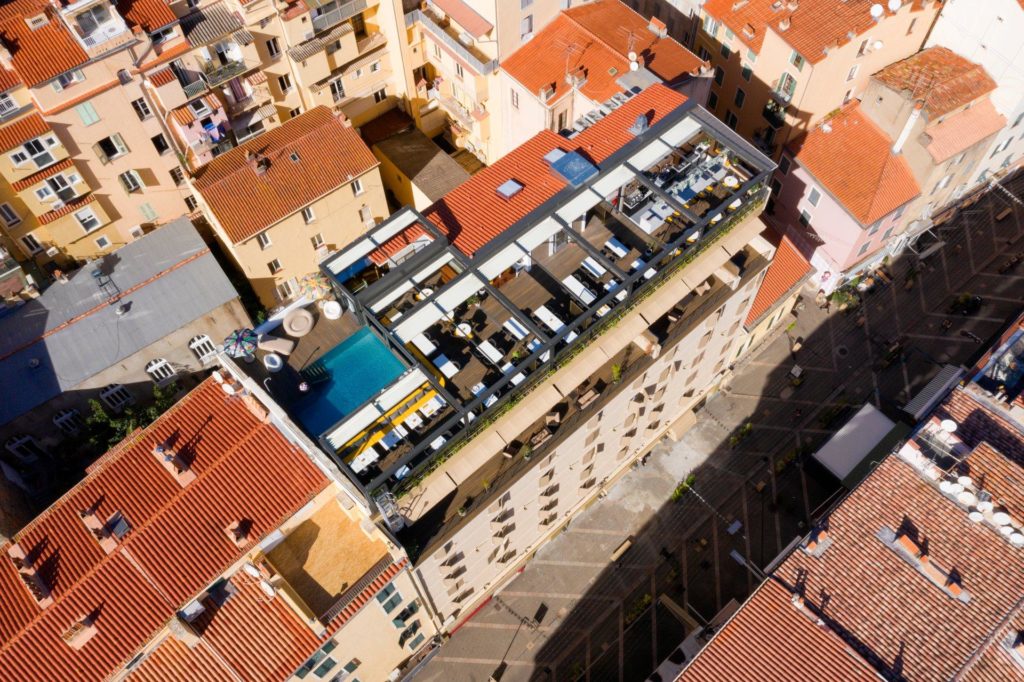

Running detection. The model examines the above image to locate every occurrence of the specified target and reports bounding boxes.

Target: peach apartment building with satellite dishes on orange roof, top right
[696,0,941,158]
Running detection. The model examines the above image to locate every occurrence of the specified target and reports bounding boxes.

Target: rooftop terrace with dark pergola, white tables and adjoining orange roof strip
[314,87,772,492]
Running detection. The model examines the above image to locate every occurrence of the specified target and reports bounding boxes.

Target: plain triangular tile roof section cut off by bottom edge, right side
[677,579,879,682]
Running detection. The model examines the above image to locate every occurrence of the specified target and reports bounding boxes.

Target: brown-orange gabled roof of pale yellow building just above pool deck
[195,106,379,244]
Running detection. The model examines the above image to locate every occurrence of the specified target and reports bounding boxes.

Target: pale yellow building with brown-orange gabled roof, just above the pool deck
[188,106,388,308]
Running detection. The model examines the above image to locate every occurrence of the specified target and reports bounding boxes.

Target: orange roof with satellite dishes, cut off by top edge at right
[703,0,938,63]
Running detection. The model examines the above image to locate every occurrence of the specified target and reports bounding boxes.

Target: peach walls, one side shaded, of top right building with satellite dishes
[695,2,939,159]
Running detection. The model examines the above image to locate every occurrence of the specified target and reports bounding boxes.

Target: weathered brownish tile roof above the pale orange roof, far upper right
[871,46,995,121]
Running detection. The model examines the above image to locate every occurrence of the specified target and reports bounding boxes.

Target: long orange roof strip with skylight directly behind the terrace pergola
[370,84,686,263]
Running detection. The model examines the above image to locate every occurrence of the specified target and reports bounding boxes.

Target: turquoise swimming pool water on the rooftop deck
[292,328,406,436]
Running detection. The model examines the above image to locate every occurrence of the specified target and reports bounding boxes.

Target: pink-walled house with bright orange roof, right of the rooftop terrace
[771,101,922,293]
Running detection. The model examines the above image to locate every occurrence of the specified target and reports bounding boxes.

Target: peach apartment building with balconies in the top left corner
[0,0,193,269]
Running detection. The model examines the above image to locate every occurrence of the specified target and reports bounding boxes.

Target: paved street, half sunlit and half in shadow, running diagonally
[417,177,1024,682]
